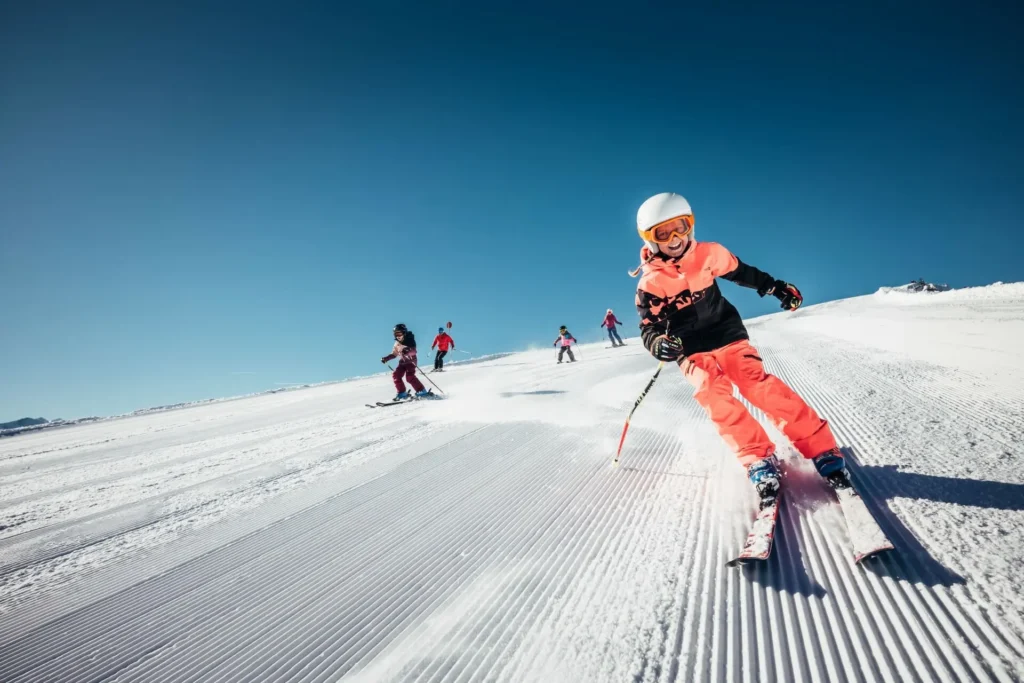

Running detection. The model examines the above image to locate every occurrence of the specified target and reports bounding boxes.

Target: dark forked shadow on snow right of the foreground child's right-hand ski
[843,447,1024,586]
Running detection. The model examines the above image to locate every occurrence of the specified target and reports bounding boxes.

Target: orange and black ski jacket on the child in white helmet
[636,242,775,355]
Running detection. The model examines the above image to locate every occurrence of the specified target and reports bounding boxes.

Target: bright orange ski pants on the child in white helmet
[680,339,836,467]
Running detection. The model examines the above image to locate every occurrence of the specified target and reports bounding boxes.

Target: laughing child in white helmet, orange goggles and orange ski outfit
[631,193,849,505]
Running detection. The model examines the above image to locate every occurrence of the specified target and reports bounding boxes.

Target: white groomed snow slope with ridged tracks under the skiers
[0,284,1024,682]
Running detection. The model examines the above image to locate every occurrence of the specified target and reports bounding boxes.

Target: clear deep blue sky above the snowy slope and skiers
[0,1,1024,421]
